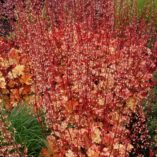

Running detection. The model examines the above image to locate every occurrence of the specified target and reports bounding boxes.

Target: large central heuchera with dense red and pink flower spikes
[2,0,156,157]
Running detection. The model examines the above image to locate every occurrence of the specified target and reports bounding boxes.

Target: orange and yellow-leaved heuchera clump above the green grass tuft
[0,39,33,110]
